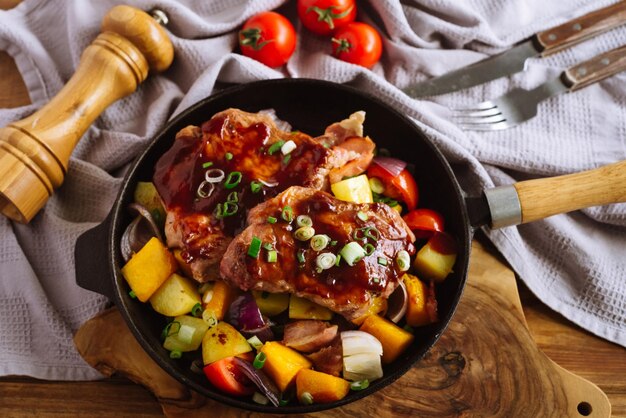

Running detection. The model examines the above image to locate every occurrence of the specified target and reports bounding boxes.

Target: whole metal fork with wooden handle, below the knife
[451,45,626,131]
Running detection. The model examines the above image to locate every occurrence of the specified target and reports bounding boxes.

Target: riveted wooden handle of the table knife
[535,0,626,56]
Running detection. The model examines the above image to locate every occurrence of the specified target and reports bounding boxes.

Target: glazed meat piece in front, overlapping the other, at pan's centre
[220,186,415,320]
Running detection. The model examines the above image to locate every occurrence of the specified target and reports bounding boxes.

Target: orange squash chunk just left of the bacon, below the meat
[261,341,312,392]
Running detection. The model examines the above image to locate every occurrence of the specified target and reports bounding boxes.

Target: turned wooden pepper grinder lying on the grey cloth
[0,6,174,223]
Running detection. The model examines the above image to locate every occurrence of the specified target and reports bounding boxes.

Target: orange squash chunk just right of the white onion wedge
[360,315,414,364]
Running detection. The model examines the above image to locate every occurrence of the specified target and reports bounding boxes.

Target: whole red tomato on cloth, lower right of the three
[332,22,383,68]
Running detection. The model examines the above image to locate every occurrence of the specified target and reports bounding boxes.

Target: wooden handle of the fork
[562,45,626,91]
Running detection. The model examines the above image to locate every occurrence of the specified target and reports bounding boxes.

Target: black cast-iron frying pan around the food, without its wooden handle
[76,79,626,413]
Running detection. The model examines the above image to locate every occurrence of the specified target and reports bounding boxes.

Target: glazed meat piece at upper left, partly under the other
[153,109,373,282]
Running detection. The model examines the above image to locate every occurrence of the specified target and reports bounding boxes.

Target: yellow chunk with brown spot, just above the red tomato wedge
[202,321,252,365]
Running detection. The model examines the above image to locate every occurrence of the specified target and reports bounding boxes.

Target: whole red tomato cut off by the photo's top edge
[298,0,356,35]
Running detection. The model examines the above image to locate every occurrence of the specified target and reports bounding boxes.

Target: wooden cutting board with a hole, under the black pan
[74,241,611,418]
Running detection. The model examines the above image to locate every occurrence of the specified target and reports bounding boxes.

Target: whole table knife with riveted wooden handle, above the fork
[404,0,626,98]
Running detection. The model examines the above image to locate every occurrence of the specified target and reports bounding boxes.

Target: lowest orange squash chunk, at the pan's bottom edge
[296,369,350,403]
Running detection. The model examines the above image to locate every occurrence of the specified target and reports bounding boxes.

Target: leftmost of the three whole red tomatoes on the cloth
[239,12,296,67]
